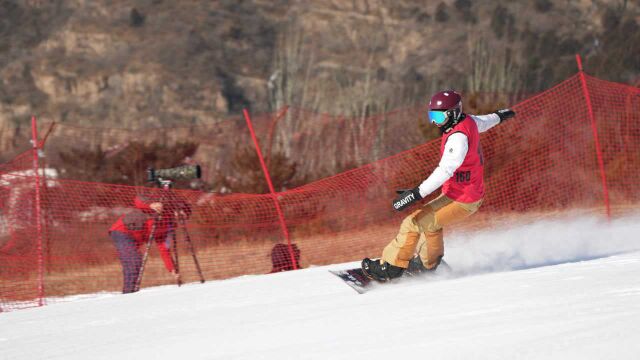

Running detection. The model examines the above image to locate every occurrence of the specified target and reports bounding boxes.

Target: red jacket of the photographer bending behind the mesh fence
[109,195,175,271]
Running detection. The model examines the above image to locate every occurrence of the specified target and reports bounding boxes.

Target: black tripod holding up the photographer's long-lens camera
[136,179,205,291]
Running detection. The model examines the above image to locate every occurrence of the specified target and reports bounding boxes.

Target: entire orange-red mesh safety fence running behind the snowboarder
[0,76,640,311]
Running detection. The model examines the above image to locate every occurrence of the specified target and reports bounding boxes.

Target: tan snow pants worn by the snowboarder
[380,194,482,269]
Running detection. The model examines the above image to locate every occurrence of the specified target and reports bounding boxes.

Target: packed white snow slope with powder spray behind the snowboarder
[0,217,640,360]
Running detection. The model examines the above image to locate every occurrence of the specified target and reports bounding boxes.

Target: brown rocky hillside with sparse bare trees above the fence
[0,0,640,160]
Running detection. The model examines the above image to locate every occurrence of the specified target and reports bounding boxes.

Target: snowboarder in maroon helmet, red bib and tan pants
[361,90,515,281]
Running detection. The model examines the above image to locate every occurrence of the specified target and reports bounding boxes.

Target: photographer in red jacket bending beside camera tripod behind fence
[109,193,191,294]
